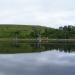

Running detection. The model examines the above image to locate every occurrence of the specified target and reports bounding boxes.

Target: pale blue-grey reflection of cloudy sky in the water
[0,50,75,75]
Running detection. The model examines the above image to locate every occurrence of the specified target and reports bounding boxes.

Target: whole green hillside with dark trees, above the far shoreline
[0,25,75,39]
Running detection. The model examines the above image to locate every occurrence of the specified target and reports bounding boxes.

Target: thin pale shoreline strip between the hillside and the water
[0,38,75,42]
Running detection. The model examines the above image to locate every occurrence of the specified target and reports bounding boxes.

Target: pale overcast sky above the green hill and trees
[0,0,75,28]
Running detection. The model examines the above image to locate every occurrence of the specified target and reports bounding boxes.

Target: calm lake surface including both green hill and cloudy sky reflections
[0,42,75,75]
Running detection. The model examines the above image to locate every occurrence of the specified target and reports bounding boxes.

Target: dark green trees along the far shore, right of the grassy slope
[30,25,75,39]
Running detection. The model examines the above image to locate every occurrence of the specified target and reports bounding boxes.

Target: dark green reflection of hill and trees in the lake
[0,41,75,53]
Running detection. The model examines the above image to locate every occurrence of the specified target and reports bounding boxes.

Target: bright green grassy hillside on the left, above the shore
[0,24,50,38]
